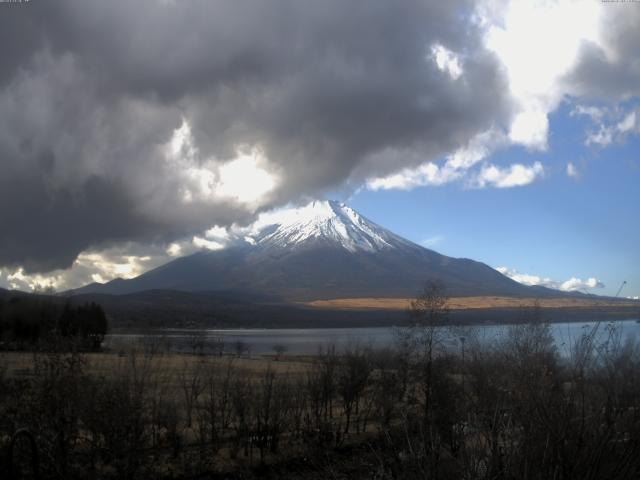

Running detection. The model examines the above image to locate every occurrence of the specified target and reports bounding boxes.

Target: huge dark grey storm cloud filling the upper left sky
[0,0,509,271]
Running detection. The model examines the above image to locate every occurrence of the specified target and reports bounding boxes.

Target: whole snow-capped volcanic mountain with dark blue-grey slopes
[73,201,567,301]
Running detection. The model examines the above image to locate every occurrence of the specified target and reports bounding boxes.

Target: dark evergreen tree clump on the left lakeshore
[0,295,109,350]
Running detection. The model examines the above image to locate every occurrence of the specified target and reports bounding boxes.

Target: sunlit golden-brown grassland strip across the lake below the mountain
[304,297,638,310]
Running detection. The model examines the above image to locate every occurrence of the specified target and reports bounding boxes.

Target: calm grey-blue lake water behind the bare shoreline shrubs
[105,319,640,355]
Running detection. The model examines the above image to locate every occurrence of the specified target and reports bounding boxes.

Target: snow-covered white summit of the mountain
[251,200,408,252]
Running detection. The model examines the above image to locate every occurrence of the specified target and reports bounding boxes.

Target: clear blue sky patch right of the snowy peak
[348,100,640,296]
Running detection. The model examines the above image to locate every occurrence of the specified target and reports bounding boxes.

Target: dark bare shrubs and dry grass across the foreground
[0,284,640,479]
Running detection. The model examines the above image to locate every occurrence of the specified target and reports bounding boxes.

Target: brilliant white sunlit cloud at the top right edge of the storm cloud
[476,0,602,150]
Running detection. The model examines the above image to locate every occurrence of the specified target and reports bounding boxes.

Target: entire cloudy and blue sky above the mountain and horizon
[0,0,640,297]
